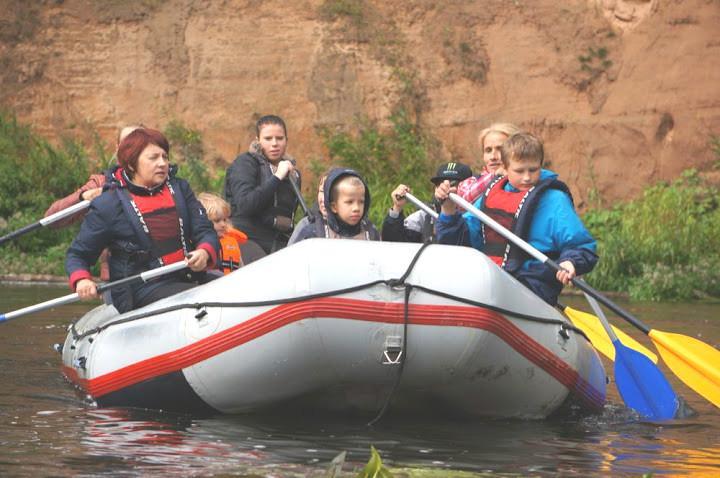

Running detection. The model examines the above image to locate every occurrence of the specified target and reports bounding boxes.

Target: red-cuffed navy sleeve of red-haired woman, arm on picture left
[65,201,113,290]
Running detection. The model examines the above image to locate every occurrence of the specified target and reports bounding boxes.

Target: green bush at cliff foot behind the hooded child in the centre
[322,110,441,228]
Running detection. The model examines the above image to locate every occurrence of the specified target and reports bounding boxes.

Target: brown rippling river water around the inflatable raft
[0,285,720,477]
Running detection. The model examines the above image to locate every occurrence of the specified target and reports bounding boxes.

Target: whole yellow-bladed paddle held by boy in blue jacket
[450,193,720,407]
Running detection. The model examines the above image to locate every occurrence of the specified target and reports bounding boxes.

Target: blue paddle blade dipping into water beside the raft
[613,340,679,420]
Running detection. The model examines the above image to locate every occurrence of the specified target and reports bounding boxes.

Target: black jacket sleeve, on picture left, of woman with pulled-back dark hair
[225,154,280,216]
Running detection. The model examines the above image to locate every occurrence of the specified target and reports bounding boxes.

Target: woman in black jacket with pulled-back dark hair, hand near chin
[225,115,300,254]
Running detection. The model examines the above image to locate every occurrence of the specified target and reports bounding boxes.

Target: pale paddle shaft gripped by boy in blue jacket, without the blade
[450,193,650,334]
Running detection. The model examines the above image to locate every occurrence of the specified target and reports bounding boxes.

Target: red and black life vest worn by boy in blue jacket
[481,177,572,273]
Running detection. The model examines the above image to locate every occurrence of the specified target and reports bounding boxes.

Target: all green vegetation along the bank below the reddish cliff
[0,109,720,300]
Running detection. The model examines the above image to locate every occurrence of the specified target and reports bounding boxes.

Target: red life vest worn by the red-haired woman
[130,183,188,265]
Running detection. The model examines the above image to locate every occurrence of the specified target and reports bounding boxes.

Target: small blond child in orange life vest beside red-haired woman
[197,193,248,275]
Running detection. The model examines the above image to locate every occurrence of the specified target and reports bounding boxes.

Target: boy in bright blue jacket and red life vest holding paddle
[435,133,598,305]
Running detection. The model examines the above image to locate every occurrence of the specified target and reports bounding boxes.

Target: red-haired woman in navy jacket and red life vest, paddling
[65,129,220,312]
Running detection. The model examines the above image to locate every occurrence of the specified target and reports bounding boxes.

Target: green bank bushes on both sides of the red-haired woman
[0,113,219,275]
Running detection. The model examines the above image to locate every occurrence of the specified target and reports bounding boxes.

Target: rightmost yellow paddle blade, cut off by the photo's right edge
[648,330,720,408]
